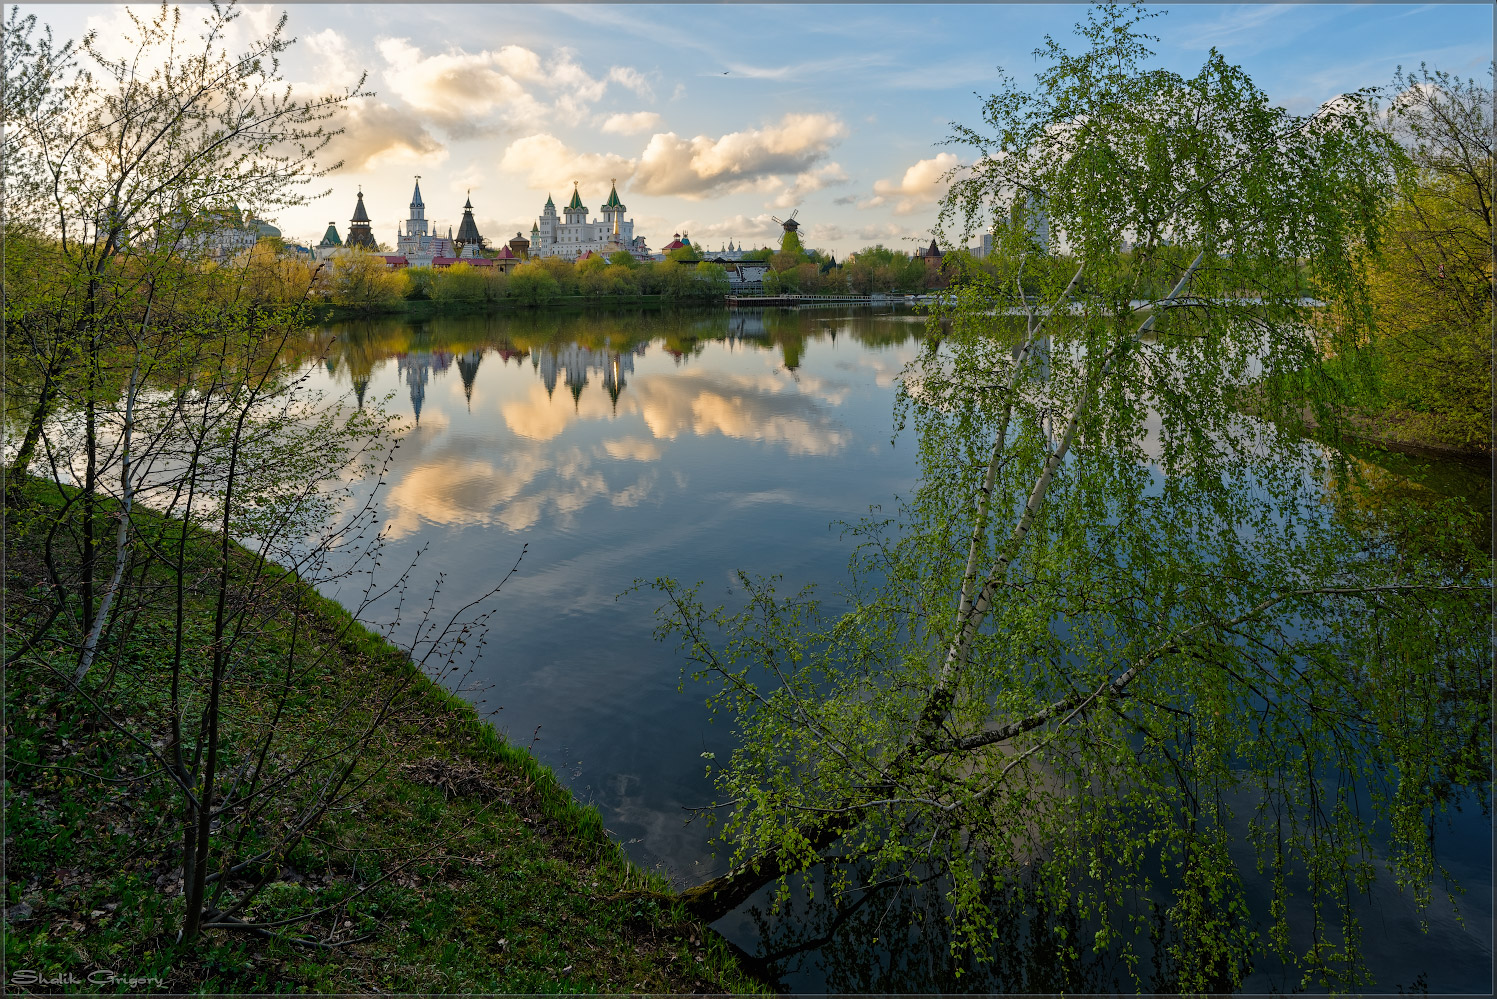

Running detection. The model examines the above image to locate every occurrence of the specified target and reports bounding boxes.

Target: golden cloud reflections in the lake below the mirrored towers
[385,338,850,538]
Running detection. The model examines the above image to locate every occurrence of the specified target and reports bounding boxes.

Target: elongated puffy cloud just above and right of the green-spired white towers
[635,114,847,199]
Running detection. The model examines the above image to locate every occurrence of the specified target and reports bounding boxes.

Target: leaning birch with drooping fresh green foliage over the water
[657,6,1491,992]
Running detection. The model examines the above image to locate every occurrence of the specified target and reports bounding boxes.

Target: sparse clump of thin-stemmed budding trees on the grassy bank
[3,3,502,947]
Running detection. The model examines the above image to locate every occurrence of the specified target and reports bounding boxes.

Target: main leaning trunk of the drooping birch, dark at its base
[680,249,1207,921]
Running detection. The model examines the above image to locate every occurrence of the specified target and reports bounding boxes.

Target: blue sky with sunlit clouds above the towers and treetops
[21,3,1493,258]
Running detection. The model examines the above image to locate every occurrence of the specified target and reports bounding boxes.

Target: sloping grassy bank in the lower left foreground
[3,481,765,993]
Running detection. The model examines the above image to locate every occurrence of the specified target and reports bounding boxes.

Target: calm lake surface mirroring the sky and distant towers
[300,307,1493,993]
